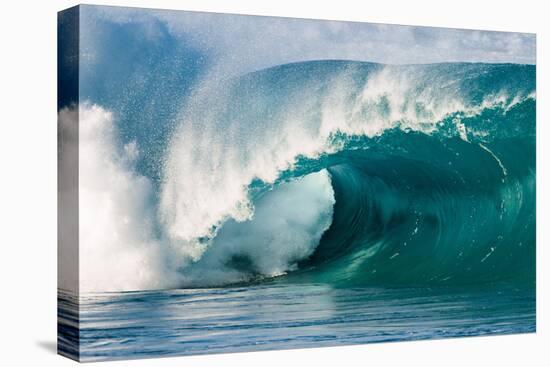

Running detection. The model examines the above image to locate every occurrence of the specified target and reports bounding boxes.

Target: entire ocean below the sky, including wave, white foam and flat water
[59,56,536,360]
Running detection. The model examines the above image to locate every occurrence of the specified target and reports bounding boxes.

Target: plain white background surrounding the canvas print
[0,0,550,367]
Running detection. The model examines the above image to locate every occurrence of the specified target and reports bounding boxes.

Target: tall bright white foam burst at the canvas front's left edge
[75,104,179,291]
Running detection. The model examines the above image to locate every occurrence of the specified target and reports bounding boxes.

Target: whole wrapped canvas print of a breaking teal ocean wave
[57,5,536,361]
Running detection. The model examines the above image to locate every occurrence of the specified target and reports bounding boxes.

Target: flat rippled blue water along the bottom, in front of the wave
[59,284,536,361]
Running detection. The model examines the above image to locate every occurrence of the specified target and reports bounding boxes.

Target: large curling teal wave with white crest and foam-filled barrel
[67,61,536,290]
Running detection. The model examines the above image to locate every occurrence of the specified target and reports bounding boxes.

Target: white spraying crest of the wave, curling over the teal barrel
[160,61,534,258]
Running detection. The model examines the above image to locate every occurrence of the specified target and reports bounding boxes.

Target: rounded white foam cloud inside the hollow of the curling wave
[182,170,334,285]
